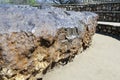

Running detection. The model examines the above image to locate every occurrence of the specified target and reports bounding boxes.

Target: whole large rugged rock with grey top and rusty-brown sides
[0,5,97,80]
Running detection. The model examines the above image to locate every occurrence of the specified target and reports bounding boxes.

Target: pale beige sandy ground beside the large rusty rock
[43,34,120,80]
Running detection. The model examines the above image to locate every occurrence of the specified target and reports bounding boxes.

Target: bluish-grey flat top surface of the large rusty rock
[0,5,97,36]
